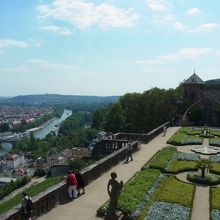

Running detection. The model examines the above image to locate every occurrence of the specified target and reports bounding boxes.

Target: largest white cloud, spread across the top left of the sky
[37,0,138,29]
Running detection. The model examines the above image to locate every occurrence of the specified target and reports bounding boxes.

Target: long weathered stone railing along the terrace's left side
[0,122,169,220]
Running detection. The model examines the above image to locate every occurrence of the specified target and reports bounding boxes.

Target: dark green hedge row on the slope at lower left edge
[0,176,30,199]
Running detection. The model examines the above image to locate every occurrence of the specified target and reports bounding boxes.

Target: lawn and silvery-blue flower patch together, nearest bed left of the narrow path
[137,176,195,220]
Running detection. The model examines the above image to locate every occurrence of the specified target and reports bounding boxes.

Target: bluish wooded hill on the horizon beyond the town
[0,94,119,105]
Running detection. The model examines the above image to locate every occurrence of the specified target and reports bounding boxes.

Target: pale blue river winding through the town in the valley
[0,109,72,156]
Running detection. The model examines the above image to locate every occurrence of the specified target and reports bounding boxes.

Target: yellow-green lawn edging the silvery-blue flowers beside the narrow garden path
[137,176,195,220]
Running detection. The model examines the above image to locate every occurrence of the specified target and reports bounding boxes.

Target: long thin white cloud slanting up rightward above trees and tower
[135,48,214,64]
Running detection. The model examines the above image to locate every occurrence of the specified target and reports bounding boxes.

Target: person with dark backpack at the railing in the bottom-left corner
[21,192,33,220]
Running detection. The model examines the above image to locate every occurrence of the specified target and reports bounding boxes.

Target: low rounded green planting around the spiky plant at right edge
[187,172,220,185]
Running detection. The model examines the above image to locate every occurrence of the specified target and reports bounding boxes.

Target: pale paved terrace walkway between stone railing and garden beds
[38,127,179,220]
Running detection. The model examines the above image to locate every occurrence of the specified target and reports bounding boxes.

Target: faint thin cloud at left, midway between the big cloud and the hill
[28,59,71,70]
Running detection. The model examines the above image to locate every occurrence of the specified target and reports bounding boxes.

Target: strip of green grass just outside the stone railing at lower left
[0,177,63,214]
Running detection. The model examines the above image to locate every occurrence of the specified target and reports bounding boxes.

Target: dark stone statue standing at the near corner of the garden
[105,172,123,220]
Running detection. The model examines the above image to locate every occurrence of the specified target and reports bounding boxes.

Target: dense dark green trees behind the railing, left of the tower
[92,85,182,133]
